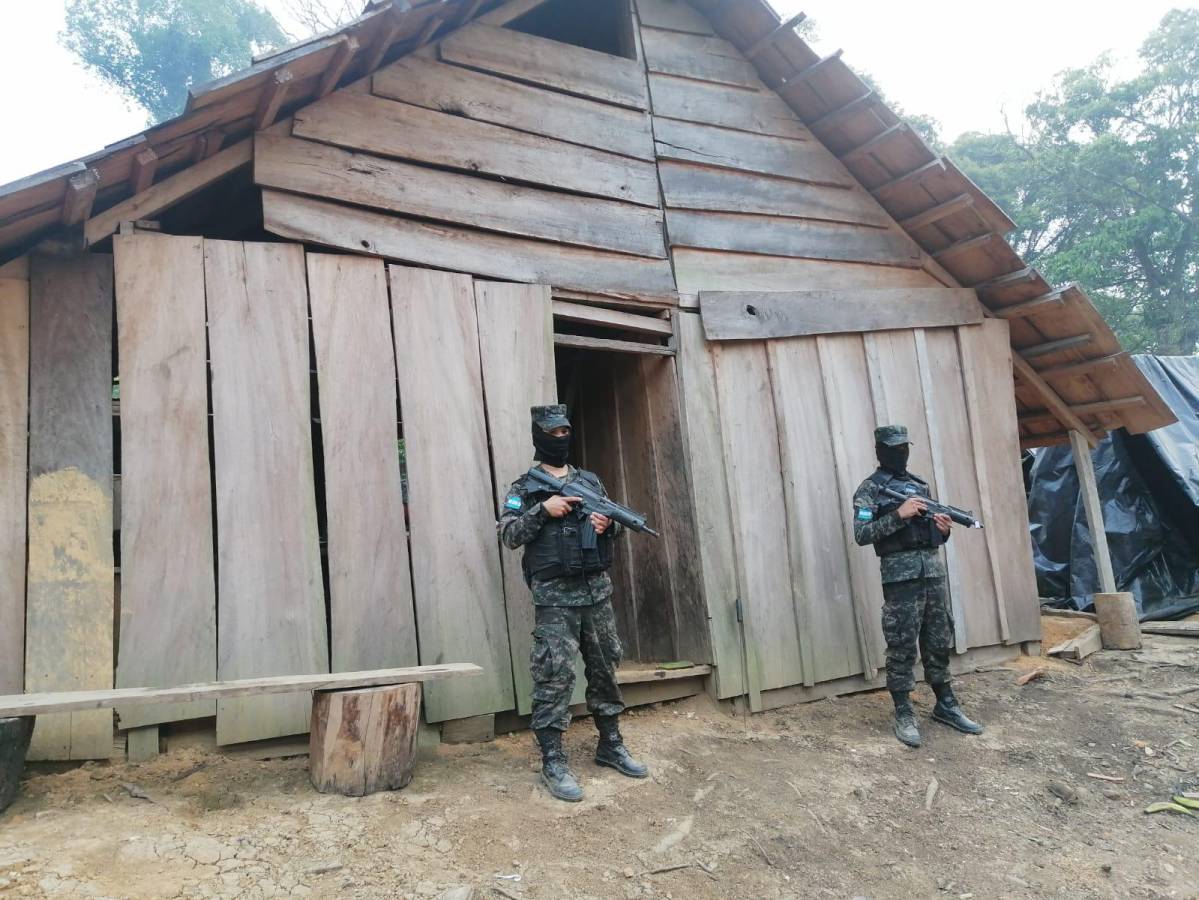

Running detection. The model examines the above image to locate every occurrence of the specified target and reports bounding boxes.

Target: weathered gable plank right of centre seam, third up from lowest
[658,159,891,228]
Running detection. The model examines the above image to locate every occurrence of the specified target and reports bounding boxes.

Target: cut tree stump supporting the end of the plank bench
[308,684,421,797]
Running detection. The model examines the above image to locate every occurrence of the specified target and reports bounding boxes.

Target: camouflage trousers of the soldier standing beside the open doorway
[529,600,625,731]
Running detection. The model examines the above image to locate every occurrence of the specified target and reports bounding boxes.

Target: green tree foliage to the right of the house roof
[948,8,1199,355]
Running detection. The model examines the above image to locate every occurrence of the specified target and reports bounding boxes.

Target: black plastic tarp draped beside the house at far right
[1029,356,1199,618]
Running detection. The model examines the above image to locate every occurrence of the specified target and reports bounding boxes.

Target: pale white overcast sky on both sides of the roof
[0,0,1192,183]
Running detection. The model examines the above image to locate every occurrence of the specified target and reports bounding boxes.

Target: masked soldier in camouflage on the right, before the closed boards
[854,425,982,747]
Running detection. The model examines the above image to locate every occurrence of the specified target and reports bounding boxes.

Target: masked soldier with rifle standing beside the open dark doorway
[499,405,649,801]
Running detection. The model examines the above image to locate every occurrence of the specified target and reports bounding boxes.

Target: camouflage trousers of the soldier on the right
[882,578,953,691]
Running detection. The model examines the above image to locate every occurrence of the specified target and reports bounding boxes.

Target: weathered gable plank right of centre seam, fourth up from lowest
[653,115,854,188]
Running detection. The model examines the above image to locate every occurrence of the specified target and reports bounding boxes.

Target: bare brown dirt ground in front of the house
[0,638,1199,900]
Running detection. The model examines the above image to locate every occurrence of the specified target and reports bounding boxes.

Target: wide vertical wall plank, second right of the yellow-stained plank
[204,241,329,744]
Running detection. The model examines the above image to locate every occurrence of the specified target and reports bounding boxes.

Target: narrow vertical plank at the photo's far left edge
[0,273,29,694]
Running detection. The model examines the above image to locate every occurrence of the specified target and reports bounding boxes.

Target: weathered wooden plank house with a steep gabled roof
[0,0,1173,759]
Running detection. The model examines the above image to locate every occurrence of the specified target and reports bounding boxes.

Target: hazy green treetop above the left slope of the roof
[60,0,285,122]
